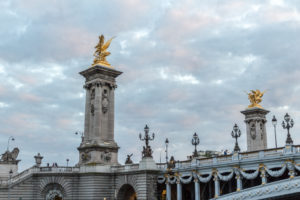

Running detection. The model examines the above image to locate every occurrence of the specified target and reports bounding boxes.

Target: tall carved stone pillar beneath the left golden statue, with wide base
[78,65,122,165]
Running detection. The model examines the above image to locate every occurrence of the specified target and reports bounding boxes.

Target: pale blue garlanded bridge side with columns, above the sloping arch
[157,145,300,199]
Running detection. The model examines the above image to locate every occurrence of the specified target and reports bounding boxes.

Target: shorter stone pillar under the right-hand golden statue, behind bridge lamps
[241,107,269,151]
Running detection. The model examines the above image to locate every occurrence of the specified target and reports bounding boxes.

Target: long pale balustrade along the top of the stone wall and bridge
[0,145,300,186]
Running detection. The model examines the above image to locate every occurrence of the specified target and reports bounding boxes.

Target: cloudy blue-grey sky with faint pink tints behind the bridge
[0,0,300,170]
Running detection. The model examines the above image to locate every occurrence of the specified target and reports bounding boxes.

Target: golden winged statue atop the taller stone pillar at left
[93,35,114,67]
